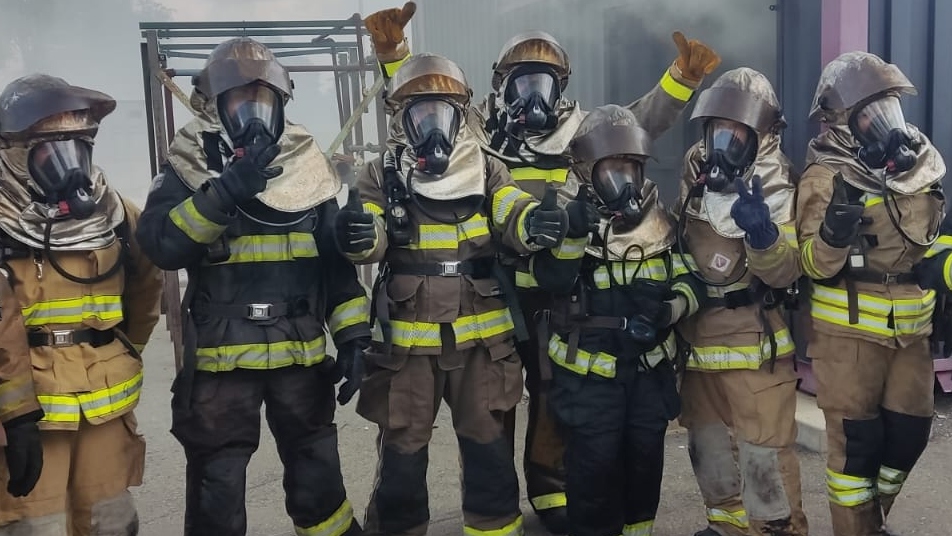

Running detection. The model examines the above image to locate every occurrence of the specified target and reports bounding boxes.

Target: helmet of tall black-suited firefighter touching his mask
[192,37,294,103]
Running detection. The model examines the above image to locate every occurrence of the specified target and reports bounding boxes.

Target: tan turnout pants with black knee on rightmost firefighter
[809,332,935,536]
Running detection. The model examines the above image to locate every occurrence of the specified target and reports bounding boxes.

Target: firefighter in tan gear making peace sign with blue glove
[678,67,807,536]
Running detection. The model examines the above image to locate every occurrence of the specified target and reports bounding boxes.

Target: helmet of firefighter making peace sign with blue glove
[691,67,787,134]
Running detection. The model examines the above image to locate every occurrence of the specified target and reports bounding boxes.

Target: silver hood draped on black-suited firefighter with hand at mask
[169,91,341,212]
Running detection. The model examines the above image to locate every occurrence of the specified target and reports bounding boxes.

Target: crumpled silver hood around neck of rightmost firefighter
[807,123,945,195]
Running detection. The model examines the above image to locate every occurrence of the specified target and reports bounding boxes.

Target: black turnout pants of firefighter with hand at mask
[172,365,360,536]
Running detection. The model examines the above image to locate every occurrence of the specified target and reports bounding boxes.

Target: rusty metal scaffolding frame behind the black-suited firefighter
[139,13,387,369]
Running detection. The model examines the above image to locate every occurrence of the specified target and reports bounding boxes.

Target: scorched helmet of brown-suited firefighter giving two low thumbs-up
[387,54,473,107]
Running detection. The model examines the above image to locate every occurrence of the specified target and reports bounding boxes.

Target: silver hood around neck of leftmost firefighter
[0,147,125,251]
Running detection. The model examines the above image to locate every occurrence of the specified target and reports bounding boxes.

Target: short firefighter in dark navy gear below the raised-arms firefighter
[530,105,704,536]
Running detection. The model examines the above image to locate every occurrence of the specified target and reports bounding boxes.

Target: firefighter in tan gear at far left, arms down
[0,74,162,536]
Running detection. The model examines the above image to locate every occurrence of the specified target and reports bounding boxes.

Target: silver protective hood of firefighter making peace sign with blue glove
[677,134,796,238]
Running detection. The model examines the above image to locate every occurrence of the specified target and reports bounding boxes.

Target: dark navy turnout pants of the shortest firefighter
[550,360,679,536]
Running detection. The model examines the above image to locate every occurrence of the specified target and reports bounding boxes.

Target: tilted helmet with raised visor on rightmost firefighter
[810,51,917,125]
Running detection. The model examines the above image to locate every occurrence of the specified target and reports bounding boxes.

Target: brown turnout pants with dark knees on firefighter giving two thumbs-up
[357,342,523,536]
